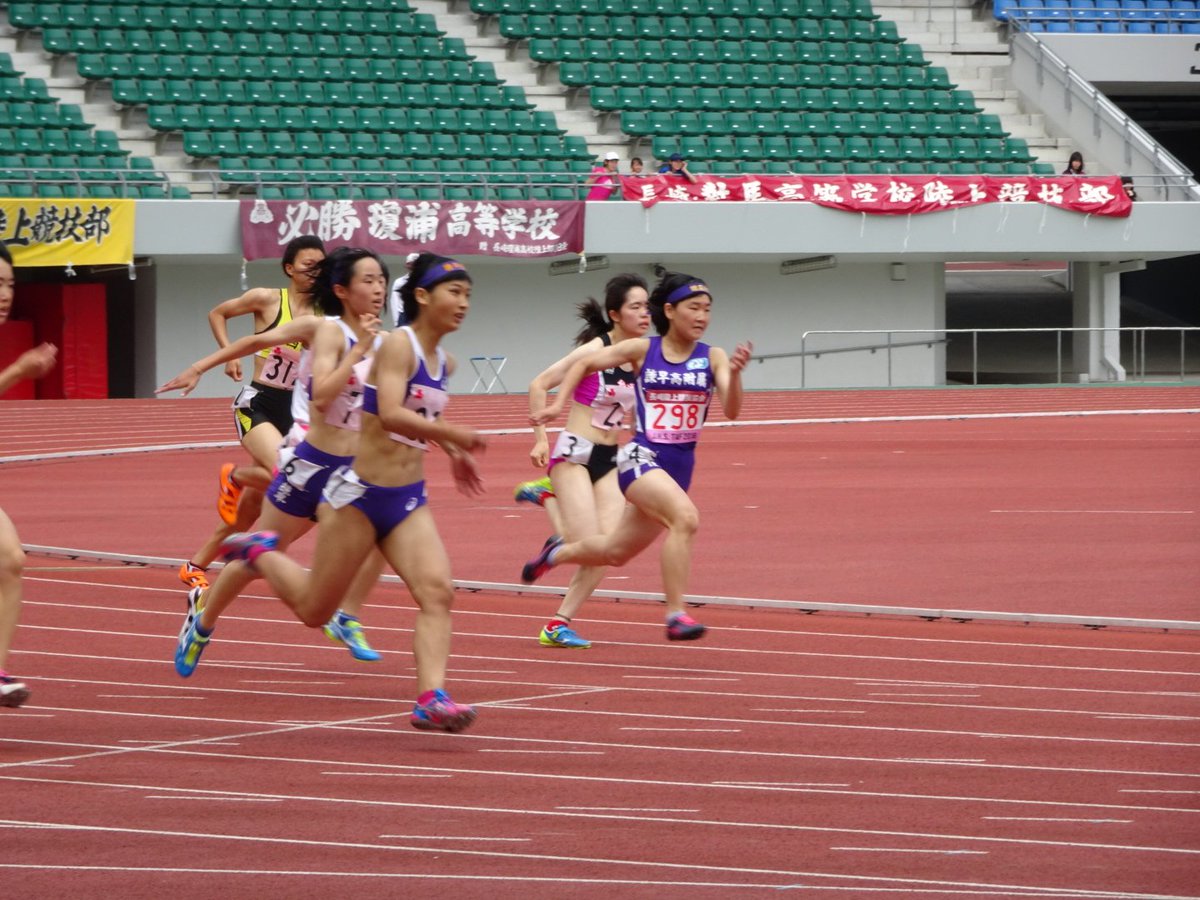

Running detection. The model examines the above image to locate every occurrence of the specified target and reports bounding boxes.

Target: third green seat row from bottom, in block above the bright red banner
[620,110,1008,138]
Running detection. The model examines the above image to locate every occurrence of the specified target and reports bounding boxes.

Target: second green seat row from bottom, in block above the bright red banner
[652,136,1033,164]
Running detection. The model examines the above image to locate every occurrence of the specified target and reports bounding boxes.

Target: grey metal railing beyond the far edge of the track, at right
[752,325,1200,388]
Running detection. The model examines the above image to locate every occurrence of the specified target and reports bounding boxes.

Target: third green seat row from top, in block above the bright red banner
[529,37,929,66]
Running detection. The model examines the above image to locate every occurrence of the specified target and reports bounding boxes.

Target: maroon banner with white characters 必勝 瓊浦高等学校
[241,200,587,259]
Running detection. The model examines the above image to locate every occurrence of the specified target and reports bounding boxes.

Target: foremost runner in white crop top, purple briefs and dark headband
[192,253,485,732]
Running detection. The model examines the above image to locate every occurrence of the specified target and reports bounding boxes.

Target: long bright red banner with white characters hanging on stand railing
[620,175,1133,216]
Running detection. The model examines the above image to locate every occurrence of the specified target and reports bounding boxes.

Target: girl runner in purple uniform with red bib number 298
[521,272,751,641]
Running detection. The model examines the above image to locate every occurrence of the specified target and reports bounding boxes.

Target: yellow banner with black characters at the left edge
[0,197,134,265]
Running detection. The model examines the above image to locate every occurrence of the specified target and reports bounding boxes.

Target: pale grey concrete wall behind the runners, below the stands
[154,259,944,397]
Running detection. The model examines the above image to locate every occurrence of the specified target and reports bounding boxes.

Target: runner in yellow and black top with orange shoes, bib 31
[179,235,325,589]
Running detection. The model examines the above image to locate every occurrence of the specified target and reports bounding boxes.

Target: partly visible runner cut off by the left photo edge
[0,242,58,707]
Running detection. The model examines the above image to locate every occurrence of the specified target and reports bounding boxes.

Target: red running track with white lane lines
[0,389,1200,900]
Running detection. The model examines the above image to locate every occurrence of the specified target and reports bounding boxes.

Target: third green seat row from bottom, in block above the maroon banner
[184,131,592,160]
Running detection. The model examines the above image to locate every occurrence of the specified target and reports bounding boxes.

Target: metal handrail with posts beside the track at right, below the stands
[772,325,1200,388]
